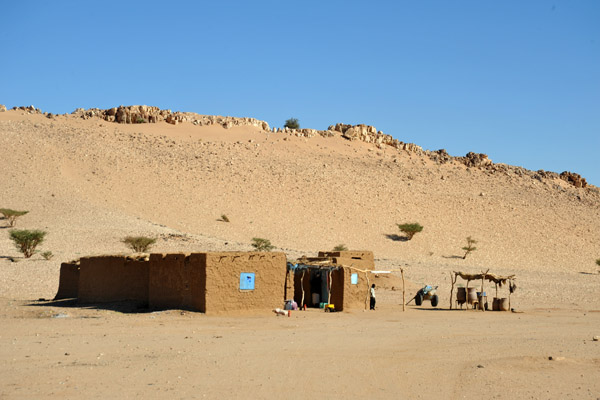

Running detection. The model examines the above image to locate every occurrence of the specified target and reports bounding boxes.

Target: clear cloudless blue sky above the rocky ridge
[0,0,600,186]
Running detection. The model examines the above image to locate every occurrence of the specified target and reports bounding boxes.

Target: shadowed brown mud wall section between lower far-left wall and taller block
[77,256,149,304]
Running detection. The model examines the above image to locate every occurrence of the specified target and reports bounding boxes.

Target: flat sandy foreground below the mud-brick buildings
[0,300,600,399]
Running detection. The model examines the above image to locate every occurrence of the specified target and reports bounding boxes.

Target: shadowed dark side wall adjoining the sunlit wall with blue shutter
[148,254,206,312]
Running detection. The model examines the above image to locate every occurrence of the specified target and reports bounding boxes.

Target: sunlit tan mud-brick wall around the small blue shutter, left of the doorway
[204,252,286,313]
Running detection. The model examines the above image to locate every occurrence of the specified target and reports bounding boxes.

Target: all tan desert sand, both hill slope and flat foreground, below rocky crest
[0,110,600,399]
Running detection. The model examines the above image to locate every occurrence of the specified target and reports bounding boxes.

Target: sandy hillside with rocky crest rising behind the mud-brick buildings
[0,106,600,271]
